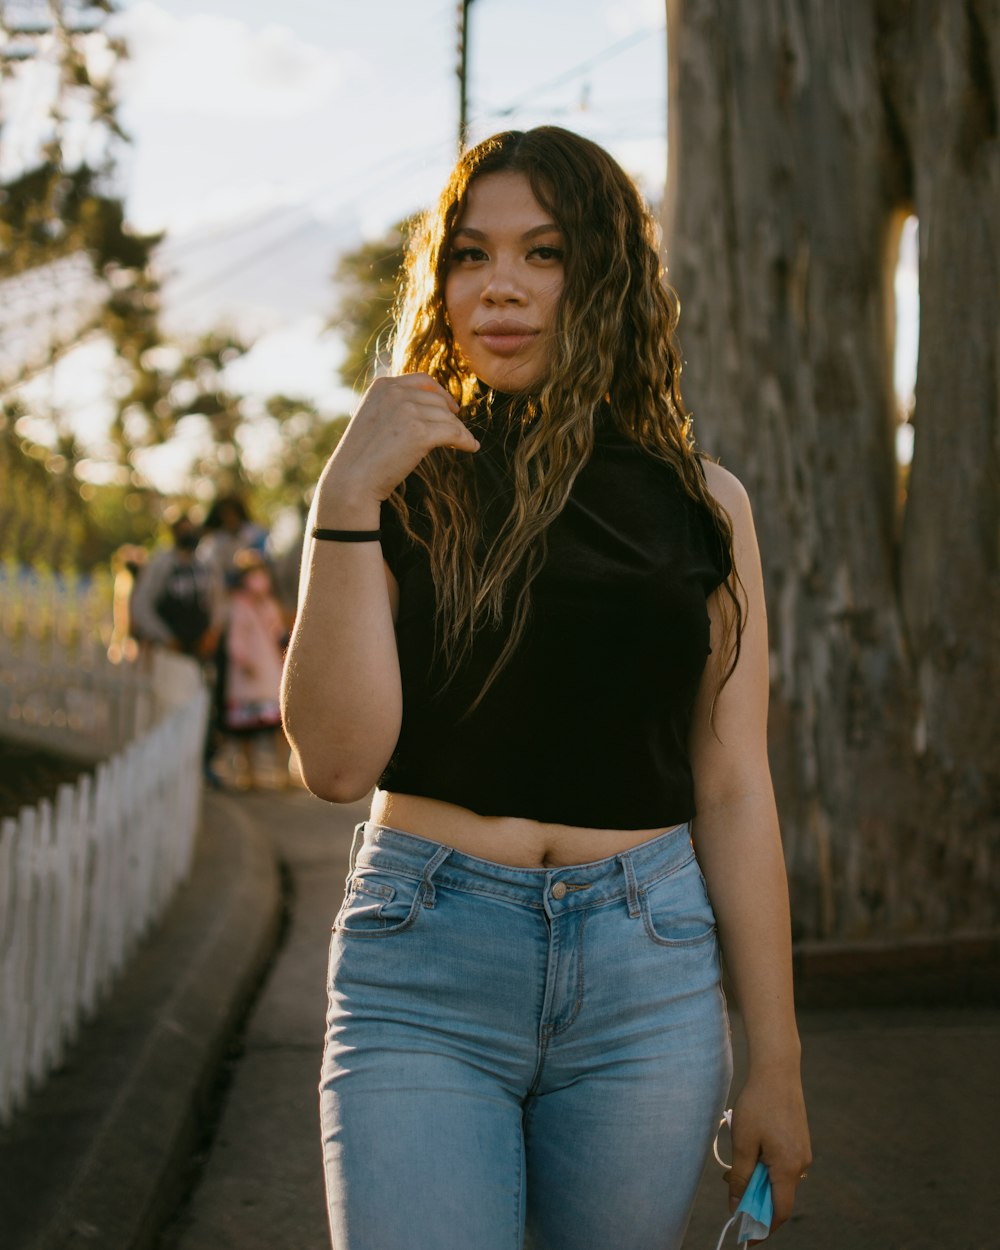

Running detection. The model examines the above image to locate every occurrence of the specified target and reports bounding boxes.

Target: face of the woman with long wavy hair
[445,174,564,391]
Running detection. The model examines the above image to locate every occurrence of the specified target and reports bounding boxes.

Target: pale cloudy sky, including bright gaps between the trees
[8,0,914,490]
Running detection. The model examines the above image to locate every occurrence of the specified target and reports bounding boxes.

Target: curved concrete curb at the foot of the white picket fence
[0,795,281,1250]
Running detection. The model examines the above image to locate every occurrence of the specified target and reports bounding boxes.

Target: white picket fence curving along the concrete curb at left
[0,575,208,1123]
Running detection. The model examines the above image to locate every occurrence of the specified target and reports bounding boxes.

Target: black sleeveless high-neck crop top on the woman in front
[379,402,730,829]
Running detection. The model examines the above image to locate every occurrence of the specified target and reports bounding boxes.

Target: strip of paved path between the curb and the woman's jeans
[154,791,366,1250]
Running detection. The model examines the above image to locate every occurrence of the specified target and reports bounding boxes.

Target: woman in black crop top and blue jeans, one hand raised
[284,128,809,1250]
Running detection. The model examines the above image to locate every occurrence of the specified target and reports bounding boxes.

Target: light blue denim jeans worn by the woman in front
[320,824,731,1250]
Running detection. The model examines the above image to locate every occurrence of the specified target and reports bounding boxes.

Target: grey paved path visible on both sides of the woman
[160,793,1000,1250]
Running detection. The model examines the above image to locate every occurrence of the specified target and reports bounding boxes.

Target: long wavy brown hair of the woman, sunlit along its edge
[390,126,743,710]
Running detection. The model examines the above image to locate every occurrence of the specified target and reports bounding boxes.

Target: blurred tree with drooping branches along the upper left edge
[0,0,160,566]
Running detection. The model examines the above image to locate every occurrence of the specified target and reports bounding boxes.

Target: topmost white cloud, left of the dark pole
[115,0,344,120]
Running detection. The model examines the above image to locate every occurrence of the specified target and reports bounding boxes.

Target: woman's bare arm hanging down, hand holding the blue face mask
[690,463,811,1229]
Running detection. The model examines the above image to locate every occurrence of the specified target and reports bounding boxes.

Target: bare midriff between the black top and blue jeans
[369,790,679,868]
